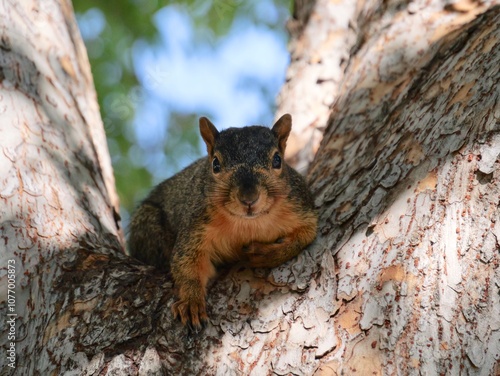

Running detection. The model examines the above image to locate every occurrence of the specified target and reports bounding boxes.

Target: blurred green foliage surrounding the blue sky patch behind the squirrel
[69,0,291,217]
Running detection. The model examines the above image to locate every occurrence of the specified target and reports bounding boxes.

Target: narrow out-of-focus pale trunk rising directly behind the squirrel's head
[277,0,358,173]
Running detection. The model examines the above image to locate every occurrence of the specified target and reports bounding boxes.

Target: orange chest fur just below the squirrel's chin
[202,203,301,262]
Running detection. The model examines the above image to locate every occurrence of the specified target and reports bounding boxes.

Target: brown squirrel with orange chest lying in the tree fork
[129,114,317,329]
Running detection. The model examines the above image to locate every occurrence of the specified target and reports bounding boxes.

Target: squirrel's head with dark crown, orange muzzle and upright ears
[200,114,292,219]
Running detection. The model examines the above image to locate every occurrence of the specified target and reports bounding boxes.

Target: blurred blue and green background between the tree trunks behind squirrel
[73,0,292,226]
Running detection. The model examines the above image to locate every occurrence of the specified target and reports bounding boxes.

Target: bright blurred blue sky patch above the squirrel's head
[134,6,289,139]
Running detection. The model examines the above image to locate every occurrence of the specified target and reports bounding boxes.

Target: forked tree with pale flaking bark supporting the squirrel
[0,0,500,375]
